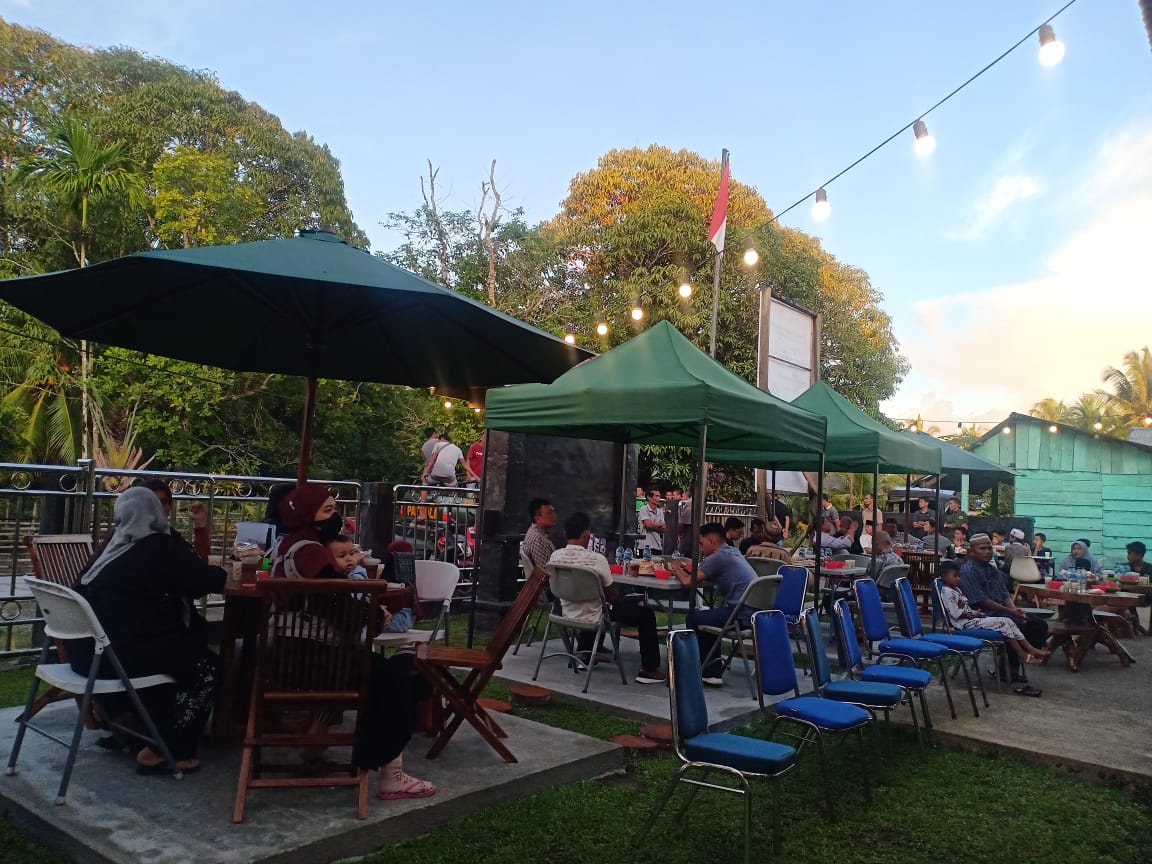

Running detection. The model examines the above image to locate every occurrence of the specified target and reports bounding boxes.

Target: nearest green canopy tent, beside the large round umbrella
[484,321,825,601]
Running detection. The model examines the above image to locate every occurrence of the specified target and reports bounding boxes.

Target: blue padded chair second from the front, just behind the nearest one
[752,609,872,819]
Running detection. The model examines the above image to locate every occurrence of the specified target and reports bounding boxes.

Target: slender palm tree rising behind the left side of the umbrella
[14,116,146,458]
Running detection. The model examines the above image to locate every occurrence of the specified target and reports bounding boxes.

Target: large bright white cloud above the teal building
[892,124,1152,419]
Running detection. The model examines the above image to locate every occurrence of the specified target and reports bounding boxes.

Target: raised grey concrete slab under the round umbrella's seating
[0,703,622,864]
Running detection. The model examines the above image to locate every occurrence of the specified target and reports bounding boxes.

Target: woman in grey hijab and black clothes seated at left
[68,487,227,774]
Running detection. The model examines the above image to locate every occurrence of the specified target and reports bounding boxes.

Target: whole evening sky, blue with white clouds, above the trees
[0,0,1152,431]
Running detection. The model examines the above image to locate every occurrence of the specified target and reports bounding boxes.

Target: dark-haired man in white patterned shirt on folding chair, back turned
[548,513,668,684]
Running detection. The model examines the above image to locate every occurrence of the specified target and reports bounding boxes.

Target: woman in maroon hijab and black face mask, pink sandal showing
[272,484,437,801]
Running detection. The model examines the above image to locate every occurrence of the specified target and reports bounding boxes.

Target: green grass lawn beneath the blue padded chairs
[0,616,1152,864]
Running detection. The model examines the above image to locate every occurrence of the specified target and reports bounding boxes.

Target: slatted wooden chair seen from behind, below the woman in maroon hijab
[233,579,388,823]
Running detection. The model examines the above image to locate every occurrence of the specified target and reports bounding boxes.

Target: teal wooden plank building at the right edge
[972,414,1152,563]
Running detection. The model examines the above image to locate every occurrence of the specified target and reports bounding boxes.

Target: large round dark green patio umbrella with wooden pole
[0,232,591,482]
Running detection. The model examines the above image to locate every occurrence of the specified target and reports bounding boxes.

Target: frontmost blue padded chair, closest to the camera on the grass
[636,630,796,864]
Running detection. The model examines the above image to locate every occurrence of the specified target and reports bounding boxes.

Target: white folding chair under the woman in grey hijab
[5,576,183,804]
